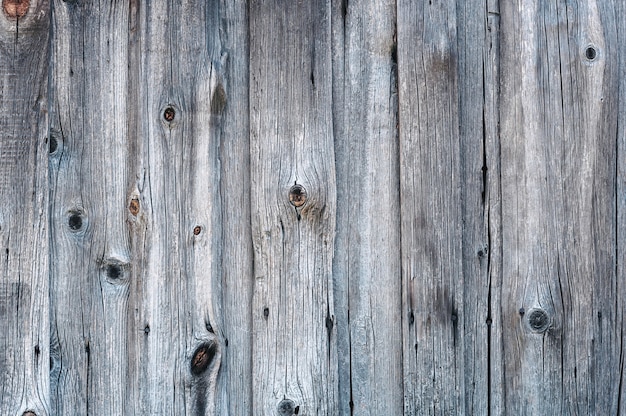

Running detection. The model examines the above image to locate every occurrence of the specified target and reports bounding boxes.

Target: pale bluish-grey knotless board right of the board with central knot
[333,1,403,415]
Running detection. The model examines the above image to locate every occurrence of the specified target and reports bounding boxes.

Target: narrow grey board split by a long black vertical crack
[450,0,501,414]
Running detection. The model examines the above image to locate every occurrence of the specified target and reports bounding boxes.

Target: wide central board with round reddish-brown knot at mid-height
[250,1,336,415]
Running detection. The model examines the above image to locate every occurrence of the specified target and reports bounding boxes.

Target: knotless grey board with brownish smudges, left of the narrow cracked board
[398,1,465,414]
